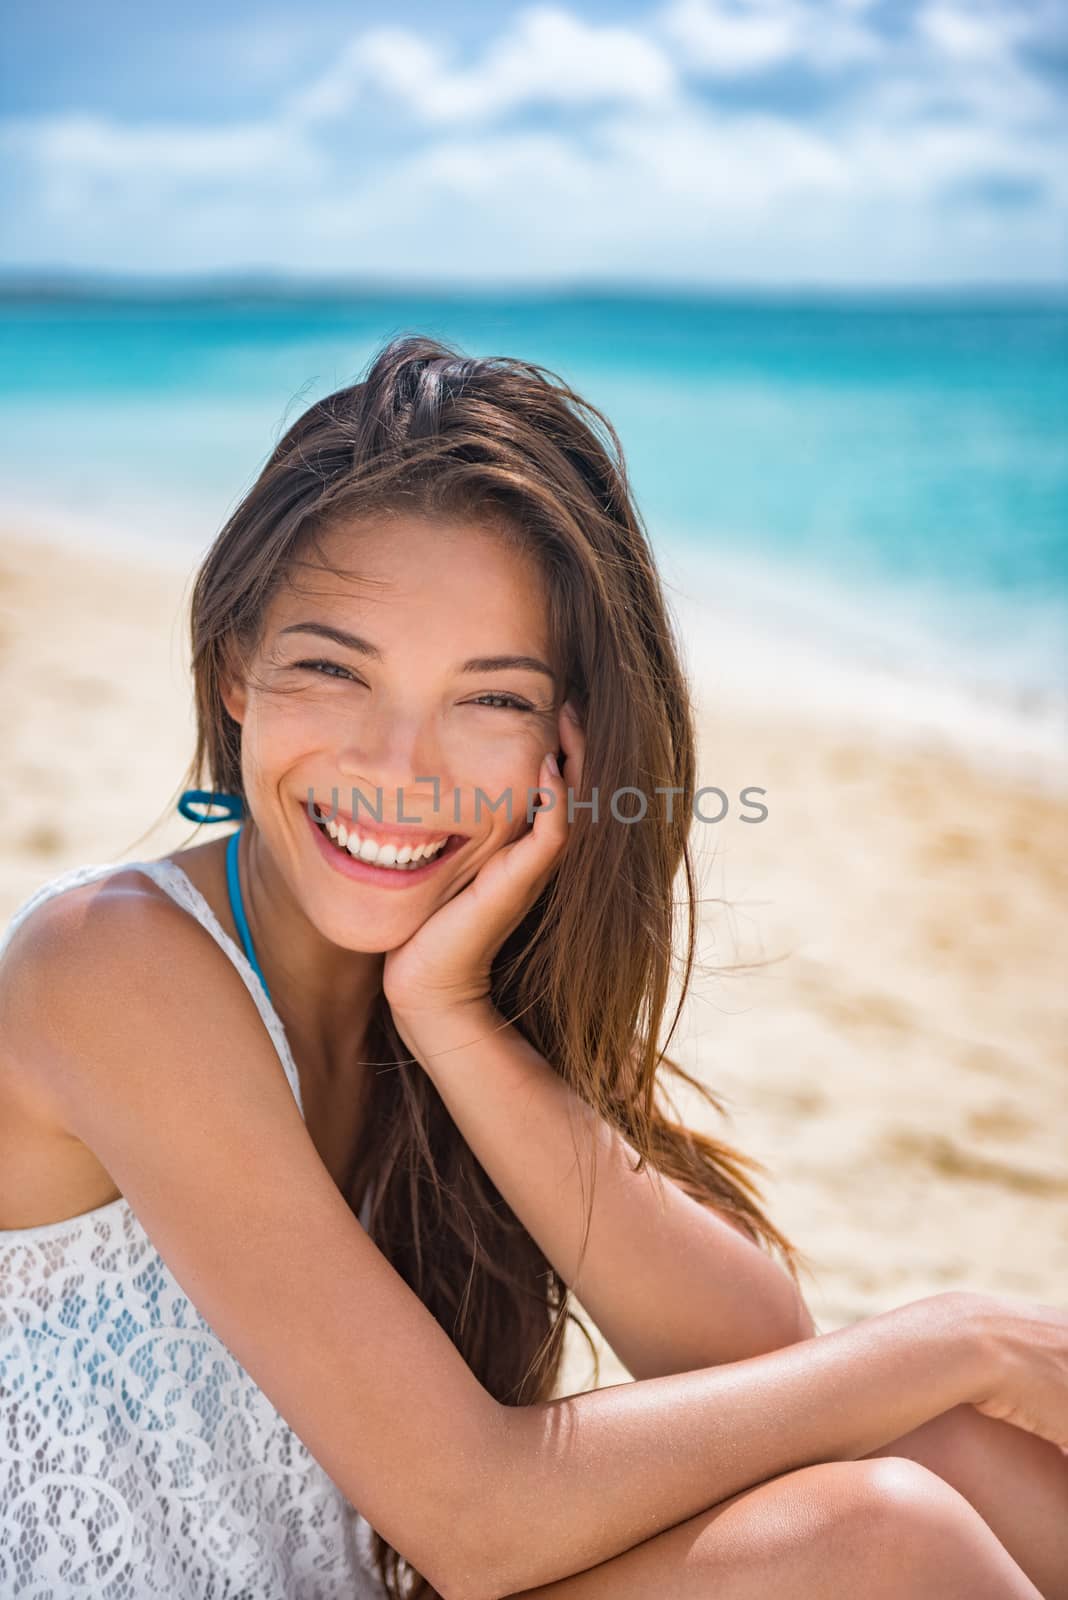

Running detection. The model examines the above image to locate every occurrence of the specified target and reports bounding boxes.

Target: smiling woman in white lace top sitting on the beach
[0,338,1068,1600]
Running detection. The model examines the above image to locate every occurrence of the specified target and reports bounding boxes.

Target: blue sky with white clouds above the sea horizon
[0,0,1068,286]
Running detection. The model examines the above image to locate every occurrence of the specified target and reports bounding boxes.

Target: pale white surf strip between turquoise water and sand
[10,502,1068,795]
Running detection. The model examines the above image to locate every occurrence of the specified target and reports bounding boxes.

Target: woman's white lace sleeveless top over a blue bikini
[0,861,384,1600]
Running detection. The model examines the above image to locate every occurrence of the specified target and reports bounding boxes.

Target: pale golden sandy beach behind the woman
[0,528,1068,1392]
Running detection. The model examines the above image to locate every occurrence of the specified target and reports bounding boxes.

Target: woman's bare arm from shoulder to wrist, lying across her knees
[0,885,986,1600]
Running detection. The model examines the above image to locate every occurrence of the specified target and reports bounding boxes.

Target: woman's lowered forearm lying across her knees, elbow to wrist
[454,1293,988,1600]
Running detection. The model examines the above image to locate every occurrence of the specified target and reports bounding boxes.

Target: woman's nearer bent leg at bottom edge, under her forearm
[510,1456,1047,1600]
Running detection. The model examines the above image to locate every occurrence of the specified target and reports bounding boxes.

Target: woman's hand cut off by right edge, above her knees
[966,1293,1068,1450]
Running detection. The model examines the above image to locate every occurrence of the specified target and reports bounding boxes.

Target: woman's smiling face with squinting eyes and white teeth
[224,517,561,952]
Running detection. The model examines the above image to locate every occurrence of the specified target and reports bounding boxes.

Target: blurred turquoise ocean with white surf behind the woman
[0,285,1068,784]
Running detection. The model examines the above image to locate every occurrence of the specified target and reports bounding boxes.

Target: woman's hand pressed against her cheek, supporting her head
[382,702,585,1032]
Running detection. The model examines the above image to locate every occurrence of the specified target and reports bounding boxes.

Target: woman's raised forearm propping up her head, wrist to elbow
[395,1003,815,1378]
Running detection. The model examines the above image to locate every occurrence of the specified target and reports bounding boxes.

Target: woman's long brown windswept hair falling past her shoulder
[173,336,807,1600]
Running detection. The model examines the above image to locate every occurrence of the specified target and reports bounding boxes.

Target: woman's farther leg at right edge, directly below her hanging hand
[863,1405,1068,1600]
